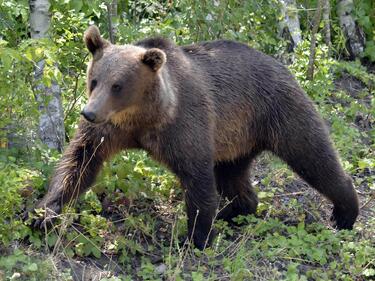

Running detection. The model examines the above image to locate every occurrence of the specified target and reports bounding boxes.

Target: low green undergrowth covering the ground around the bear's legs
[0,42,375,281]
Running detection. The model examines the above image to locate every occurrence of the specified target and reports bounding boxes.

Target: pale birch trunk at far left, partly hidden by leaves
[29,0,65,151]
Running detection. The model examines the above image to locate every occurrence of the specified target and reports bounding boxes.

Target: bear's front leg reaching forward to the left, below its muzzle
[34,120,118,228]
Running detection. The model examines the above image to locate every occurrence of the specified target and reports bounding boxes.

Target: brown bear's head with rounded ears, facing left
[82,26,166,123]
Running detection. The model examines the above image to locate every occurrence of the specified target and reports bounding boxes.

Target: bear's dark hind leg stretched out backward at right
[274,125,359,229]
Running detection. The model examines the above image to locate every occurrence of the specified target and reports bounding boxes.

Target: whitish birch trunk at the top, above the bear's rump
[279,0,302,49]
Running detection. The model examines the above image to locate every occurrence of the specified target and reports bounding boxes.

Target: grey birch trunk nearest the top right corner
[337,0,365,59]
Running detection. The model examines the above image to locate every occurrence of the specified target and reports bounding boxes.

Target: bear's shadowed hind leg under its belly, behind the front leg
[215,154,258,222]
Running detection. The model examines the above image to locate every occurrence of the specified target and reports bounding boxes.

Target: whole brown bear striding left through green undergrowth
[35,26,358,249]
